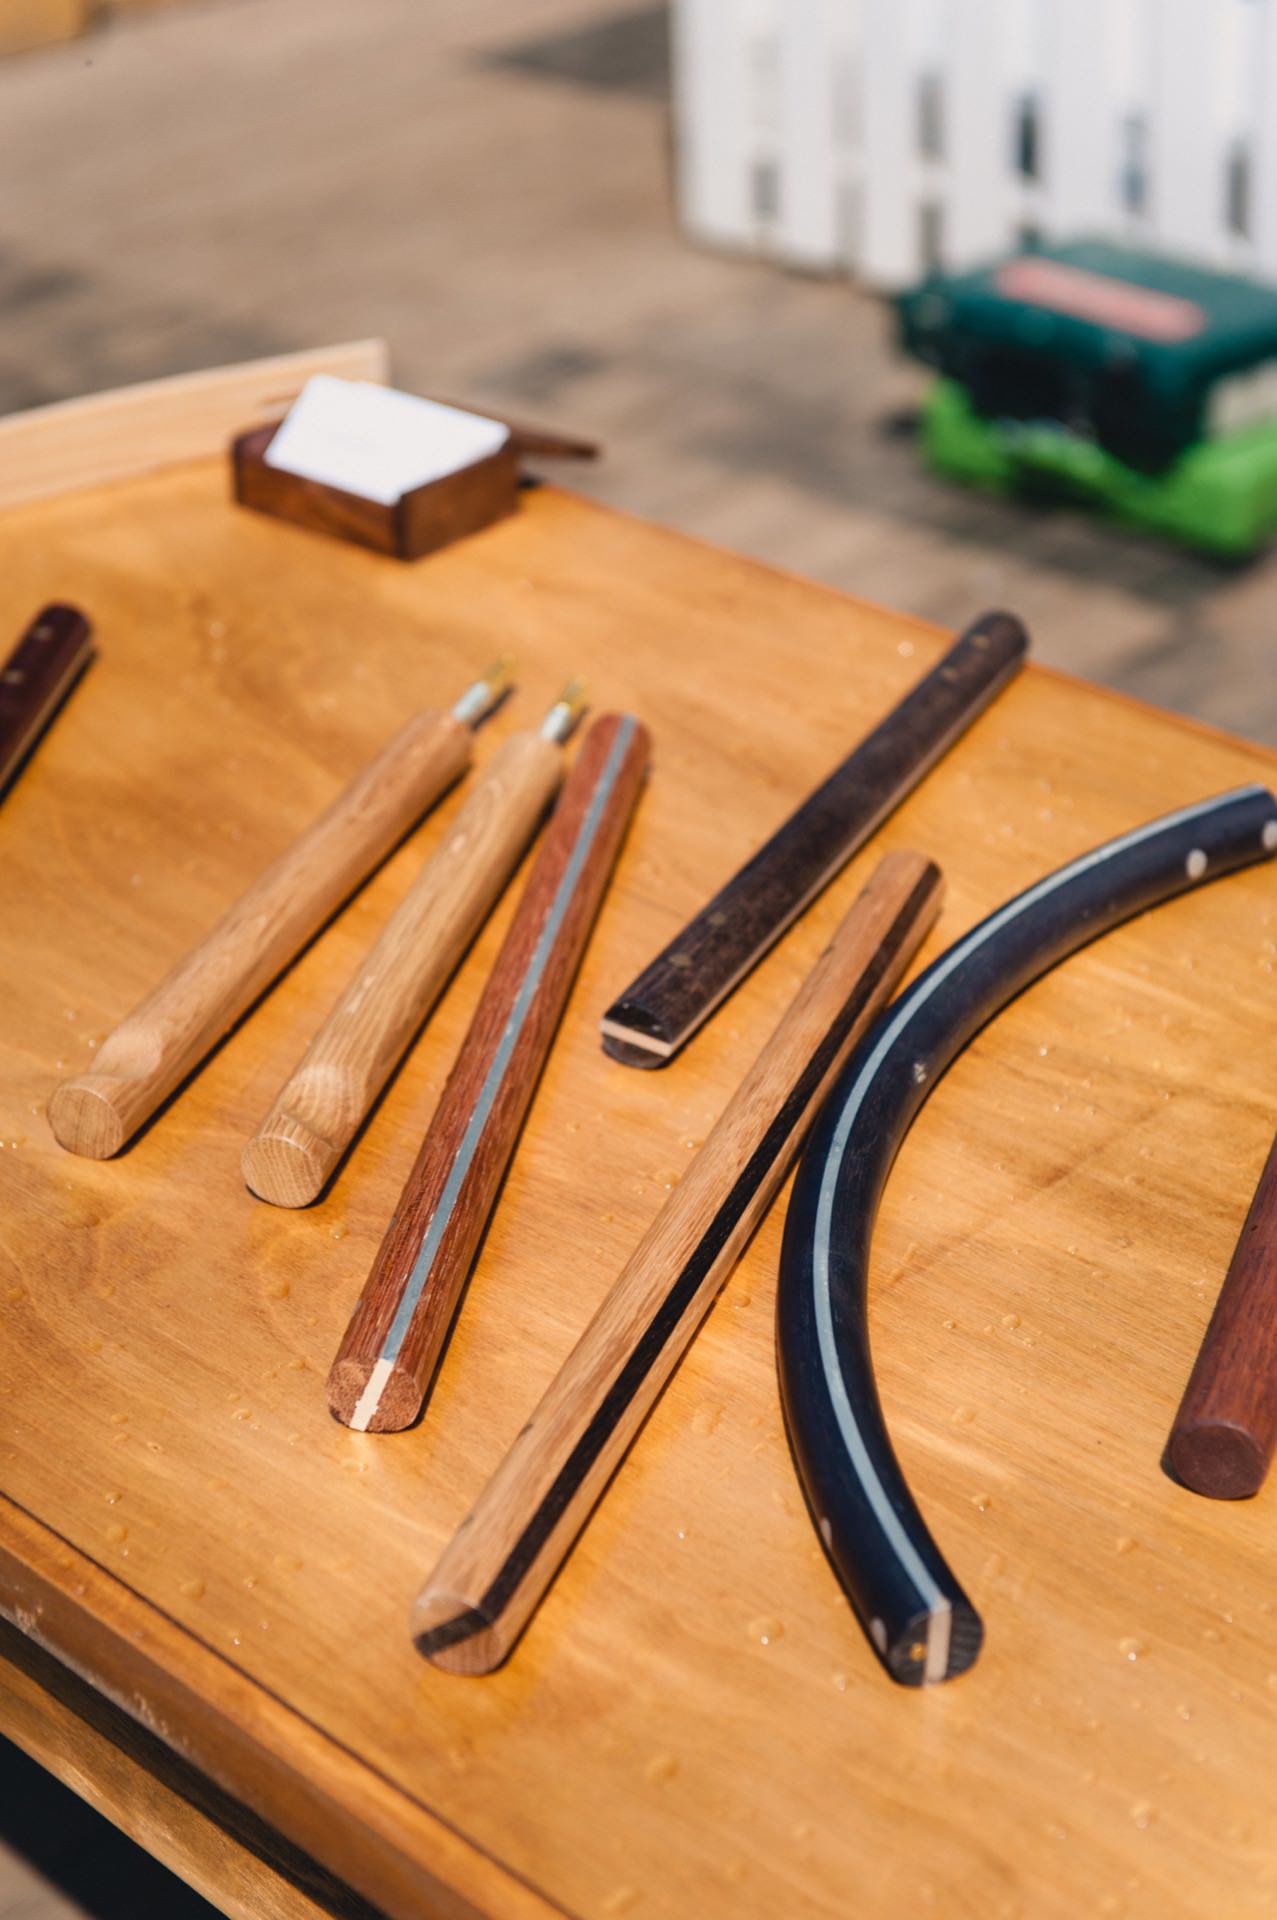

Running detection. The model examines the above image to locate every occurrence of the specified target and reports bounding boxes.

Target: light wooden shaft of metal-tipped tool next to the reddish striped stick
[244,733,563,1206]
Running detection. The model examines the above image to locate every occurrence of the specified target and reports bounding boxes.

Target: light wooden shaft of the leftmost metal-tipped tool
[48,708,470,1160]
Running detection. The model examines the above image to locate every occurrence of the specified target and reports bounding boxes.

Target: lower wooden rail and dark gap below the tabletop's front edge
[0,1622,378,1920]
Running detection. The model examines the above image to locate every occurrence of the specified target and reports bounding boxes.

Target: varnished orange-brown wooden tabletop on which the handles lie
[0,463,1277,1920]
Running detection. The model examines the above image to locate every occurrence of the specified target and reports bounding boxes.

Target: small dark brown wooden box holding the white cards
[230,420,520,561]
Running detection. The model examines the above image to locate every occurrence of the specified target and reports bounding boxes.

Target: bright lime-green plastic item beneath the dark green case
[922,380,1277,559]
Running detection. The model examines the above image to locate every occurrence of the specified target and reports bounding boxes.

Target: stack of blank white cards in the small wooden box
[265,372,511,507]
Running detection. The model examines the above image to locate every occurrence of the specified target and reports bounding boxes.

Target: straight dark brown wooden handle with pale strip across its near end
[601,612,1029,1068]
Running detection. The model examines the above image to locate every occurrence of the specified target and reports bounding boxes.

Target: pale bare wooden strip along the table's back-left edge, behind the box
[0,340,390,507]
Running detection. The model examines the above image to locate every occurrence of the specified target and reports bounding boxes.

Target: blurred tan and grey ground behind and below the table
[0,0,1277,1920]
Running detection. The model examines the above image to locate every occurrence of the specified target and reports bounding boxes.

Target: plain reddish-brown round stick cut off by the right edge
[1169,1140,1277,1500]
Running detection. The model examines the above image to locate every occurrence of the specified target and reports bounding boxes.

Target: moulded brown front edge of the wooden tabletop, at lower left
[0,1496,563,1920]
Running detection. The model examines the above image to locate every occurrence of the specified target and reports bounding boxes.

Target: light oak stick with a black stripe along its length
[413,852,941,1674]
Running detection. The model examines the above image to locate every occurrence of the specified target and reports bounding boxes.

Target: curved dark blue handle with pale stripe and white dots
[778,787,1277,1686]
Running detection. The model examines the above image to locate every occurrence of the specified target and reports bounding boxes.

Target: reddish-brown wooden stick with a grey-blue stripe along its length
[328,714,649,1432]
